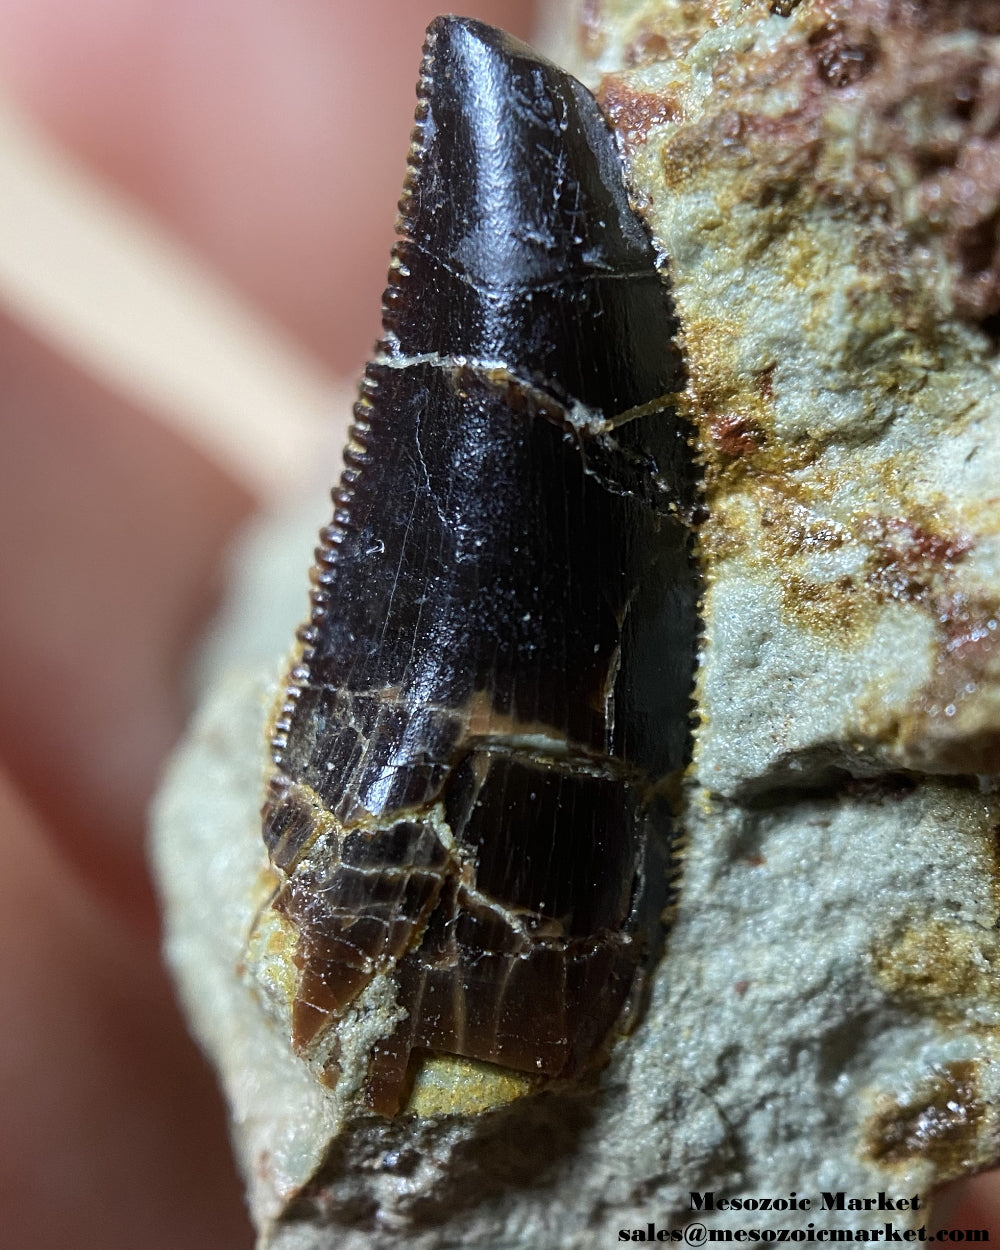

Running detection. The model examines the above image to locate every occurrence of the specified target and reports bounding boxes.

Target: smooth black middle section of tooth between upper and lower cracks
[287,364,689,795]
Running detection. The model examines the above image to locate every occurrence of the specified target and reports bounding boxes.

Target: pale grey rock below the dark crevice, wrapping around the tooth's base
[155,512,1000,1250]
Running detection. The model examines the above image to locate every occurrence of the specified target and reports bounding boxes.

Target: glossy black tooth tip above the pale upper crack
[386,19,684,416]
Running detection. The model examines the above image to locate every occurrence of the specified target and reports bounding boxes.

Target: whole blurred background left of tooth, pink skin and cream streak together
[0,0,1000,1250]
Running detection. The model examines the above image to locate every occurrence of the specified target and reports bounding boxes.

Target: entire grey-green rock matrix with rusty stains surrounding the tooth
[148,0,1000,1250]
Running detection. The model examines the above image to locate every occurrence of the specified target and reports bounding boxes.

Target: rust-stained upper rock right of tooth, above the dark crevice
[588,0,1000,796]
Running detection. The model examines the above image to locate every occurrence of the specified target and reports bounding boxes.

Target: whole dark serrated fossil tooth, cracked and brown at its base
[264,19,696,1114]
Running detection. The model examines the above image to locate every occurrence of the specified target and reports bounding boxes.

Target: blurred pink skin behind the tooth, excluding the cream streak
[0,0,1000,1250]
